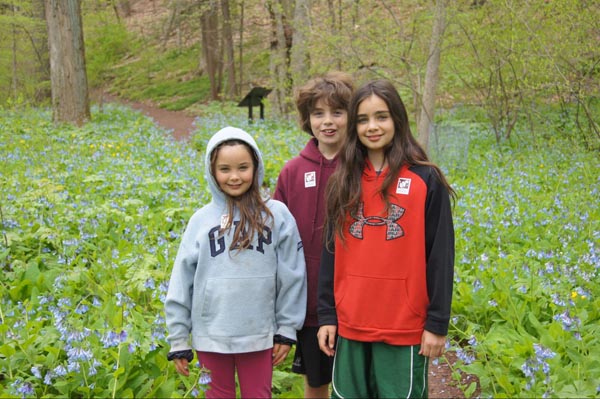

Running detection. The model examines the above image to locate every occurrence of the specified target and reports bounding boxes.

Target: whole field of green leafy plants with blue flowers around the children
[0,105,600,397]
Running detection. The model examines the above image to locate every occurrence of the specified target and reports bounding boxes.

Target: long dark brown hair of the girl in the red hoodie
[325,80,456,246]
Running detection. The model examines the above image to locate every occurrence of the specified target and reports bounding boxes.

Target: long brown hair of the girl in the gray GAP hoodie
[210,139,273,251]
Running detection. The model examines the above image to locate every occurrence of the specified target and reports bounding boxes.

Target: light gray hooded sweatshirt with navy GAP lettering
[165,127,306,353]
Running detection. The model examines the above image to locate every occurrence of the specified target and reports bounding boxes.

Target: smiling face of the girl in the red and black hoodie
[356,94,395,159]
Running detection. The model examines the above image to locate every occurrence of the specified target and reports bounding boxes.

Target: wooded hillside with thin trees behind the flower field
[0,0,600,148]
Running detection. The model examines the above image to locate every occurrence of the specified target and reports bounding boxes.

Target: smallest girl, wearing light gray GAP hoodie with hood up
[165,127,306,398]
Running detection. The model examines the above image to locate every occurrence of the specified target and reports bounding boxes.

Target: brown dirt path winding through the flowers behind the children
[92,93,472,399]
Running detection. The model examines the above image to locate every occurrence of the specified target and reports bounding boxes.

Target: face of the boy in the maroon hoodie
[310,100,348,157]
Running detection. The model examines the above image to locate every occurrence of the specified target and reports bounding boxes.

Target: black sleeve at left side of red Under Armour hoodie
[317,229,337,326]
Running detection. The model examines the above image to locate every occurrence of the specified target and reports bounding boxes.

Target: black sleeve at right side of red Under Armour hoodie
[425,168,454,335]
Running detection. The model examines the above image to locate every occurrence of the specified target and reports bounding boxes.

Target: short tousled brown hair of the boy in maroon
[296,71,354,136]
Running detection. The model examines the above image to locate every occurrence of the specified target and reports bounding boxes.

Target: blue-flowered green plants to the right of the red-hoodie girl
[450,123,600,397]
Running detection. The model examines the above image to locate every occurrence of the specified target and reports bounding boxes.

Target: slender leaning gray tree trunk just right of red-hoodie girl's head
[417,0,446,151]
